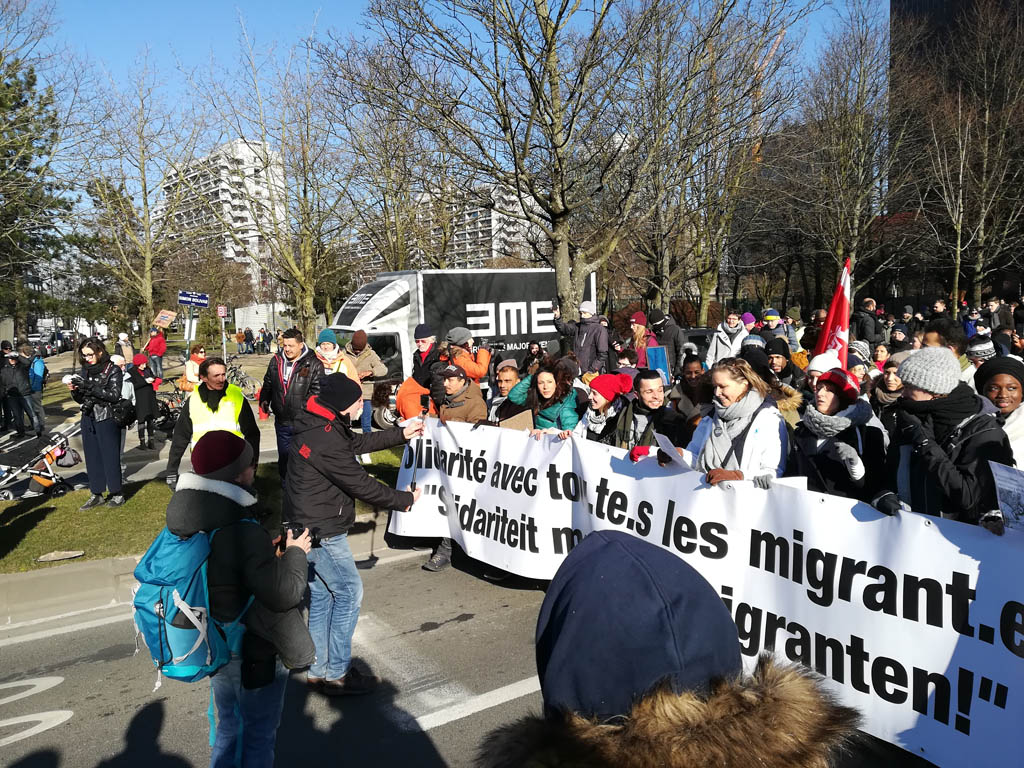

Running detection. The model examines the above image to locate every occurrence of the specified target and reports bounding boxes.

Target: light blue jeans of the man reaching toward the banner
[307,534,362,680]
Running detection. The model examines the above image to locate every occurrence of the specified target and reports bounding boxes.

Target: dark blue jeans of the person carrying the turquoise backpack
[210,654,288,768]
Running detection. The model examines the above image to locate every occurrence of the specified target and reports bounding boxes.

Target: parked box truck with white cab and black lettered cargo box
[331,269,596,426]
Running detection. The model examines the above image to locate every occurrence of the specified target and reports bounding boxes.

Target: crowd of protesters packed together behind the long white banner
[398,297,1024,548]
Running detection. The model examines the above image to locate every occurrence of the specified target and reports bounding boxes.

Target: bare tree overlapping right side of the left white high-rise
[196,25,360,336]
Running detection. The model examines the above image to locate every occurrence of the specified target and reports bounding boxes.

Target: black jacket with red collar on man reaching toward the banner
[284,396,413,539]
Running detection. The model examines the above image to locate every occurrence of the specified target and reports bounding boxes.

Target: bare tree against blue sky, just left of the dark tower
[787,0,916,288]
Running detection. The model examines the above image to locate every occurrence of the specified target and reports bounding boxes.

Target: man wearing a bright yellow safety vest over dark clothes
[167,357,259,487]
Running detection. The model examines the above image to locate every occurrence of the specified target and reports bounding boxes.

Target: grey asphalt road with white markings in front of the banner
[0,539,543,768]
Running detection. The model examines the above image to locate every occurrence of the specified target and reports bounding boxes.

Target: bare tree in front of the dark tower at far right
[921,0,1024,306]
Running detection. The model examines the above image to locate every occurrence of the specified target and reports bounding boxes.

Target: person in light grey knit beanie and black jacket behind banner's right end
[872,347,1013,532]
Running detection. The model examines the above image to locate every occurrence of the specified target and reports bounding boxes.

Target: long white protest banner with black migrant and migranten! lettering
[389,419,1024,766]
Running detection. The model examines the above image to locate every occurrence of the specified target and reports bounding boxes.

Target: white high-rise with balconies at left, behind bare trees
[156,138,284,287]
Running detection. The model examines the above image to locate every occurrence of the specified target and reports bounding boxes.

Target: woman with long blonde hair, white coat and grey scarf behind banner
[682,357,788,486]
